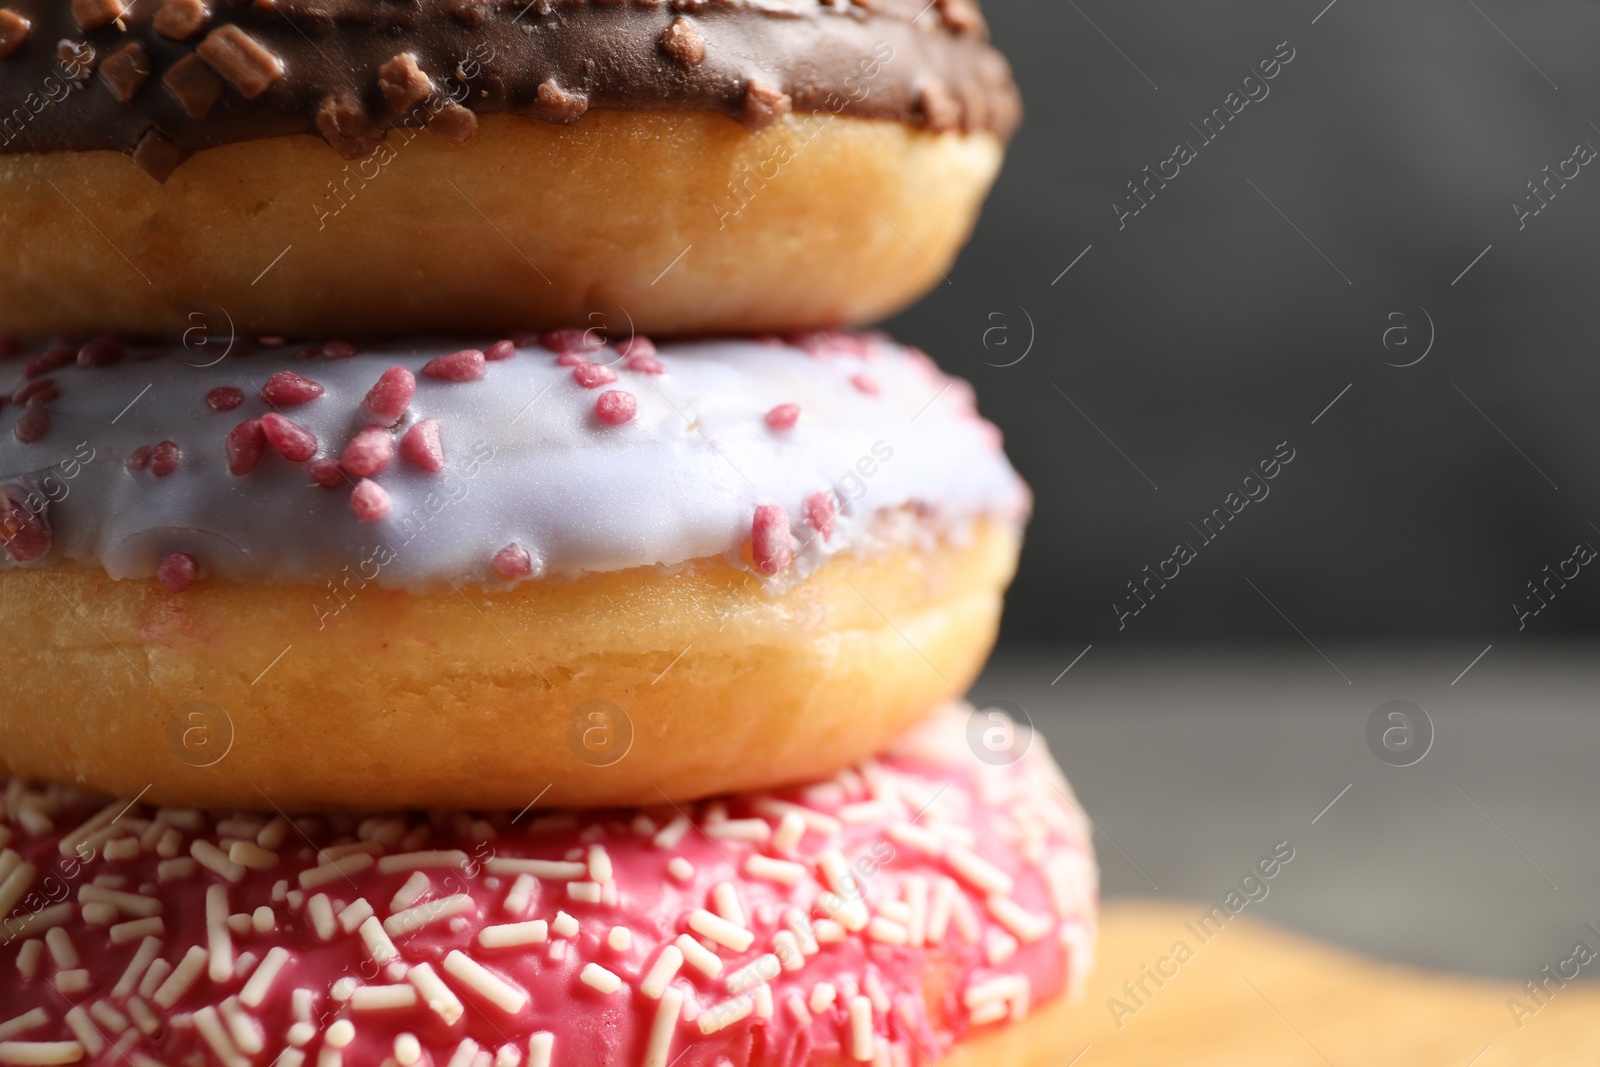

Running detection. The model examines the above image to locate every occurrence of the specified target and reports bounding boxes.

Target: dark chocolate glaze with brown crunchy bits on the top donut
[0,0,1019,181]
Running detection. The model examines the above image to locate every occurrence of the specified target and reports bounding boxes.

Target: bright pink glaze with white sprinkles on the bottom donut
[0,709,1096,1067]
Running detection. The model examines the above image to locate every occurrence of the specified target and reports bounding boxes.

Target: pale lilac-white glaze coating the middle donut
[0,338,1030,590]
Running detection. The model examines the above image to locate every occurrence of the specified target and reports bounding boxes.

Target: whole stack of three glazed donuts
[0,0,1098,1067]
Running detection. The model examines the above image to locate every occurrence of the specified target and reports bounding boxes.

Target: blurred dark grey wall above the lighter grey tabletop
[888,0,1600,643]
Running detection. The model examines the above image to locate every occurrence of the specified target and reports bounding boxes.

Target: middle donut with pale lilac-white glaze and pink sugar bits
[0,331,1029,809]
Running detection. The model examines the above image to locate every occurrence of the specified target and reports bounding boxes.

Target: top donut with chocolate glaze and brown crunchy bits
[0,0,1019,333]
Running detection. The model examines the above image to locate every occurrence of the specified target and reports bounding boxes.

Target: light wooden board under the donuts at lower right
[1051,901,1600,1067]
